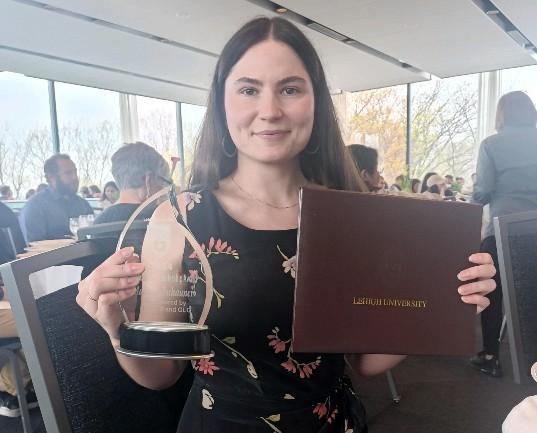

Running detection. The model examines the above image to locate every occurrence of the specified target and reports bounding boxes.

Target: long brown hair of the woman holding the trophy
[189,17,367,191]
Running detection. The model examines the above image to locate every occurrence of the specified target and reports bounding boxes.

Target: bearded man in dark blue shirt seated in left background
[20,153,93,242]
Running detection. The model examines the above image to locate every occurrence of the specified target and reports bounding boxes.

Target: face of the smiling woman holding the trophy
[225,40,315,164]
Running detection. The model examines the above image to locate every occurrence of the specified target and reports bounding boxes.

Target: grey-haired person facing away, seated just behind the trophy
[95,141,170,224]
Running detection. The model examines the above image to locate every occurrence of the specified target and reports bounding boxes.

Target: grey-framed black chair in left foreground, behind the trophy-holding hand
[0,239,191,433]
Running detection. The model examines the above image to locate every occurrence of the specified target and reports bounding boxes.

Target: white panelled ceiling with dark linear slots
[0,0,537,104]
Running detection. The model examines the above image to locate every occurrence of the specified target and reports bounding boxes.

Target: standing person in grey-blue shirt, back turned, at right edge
[470,92,537,377]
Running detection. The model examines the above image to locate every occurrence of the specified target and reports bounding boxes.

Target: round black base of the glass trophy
[117,322,213,360]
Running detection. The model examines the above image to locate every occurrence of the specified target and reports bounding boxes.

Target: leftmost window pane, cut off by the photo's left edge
[0,72,53,199]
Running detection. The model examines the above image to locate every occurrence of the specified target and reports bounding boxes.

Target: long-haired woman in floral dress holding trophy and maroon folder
[77,18,494,433]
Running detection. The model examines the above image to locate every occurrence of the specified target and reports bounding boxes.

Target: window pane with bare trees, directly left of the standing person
[410,74,479,179]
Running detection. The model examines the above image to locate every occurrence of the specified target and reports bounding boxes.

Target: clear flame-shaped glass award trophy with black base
[116,185,213,360]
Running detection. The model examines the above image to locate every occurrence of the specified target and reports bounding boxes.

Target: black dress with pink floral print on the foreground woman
[178,189,366,433]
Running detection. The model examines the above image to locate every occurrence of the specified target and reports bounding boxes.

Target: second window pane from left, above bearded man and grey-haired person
[56,83,122,187]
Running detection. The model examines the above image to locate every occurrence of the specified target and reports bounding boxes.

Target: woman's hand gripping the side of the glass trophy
[76,247,144,339]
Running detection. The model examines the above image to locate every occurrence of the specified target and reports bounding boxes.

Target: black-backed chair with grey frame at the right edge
[494,211,537,384]
